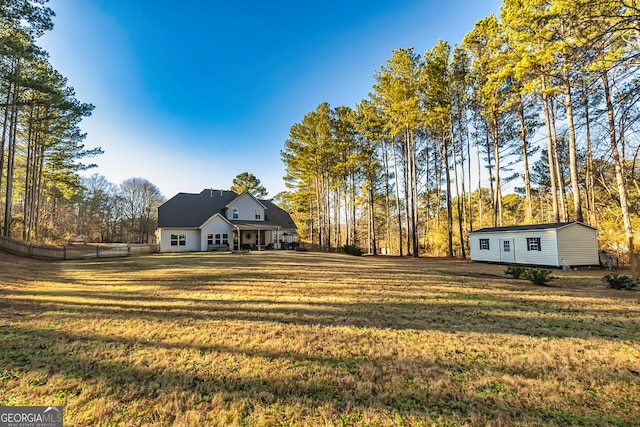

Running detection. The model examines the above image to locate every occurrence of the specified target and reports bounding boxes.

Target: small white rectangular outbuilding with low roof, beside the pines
[469,222,600,267]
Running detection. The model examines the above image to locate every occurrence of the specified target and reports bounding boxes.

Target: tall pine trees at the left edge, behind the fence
[0,0,102,241]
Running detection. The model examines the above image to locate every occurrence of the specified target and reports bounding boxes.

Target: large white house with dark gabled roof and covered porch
[157,189,297,252]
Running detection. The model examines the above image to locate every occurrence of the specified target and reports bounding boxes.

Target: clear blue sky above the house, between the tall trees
[39,0,501,197]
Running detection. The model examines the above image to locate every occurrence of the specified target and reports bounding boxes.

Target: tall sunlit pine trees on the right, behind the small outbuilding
[278,0,640,257]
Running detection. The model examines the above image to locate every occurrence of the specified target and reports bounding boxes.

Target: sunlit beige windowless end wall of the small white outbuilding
[558,224,600,266]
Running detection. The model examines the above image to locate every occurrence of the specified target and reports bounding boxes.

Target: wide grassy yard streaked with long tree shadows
[0,252,640,426]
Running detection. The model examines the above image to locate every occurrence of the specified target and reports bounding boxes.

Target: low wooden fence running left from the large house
[0,236,160,260]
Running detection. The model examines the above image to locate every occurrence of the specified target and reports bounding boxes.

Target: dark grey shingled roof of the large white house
[158,189,296,228]
